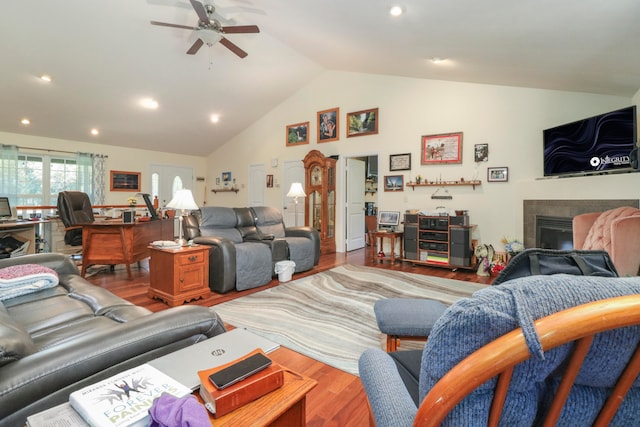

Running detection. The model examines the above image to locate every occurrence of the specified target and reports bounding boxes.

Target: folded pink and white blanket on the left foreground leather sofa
[0,264,58,301]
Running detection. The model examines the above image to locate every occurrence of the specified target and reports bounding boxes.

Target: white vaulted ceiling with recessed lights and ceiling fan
[0,0,640,155]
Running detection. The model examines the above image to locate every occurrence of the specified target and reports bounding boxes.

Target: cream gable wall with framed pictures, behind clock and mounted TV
[207,71,640,251]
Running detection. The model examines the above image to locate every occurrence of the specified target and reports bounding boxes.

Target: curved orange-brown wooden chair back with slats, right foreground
[414,295,640,426]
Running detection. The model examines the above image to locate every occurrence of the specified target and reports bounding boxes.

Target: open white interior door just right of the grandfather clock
[346,158,365,252]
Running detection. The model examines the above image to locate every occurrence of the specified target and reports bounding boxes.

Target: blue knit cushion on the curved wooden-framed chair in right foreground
[420,274,640,425]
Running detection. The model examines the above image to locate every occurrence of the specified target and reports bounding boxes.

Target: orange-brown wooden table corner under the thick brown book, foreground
[210,347,317,427]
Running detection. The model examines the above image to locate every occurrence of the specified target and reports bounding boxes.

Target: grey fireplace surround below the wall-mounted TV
[522,199,640,248]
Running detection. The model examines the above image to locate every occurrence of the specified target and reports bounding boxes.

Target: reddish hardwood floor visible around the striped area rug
[88,247,491,427]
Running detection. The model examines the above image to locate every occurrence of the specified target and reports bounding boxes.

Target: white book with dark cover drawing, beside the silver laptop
[69,364,191,427]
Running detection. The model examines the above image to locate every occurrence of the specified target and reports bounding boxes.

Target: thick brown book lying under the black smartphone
[198,349,284,418]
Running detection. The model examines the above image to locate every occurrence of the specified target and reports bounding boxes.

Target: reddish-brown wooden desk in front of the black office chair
[82,219,174,279]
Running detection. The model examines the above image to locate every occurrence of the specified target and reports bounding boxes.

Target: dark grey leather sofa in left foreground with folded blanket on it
[0,254,225,427]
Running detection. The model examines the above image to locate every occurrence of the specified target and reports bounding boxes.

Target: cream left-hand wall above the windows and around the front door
[0,132,206,205]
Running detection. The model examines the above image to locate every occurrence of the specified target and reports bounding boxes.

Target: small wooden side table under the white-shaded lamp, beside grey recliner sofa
[149,245,211,307]
